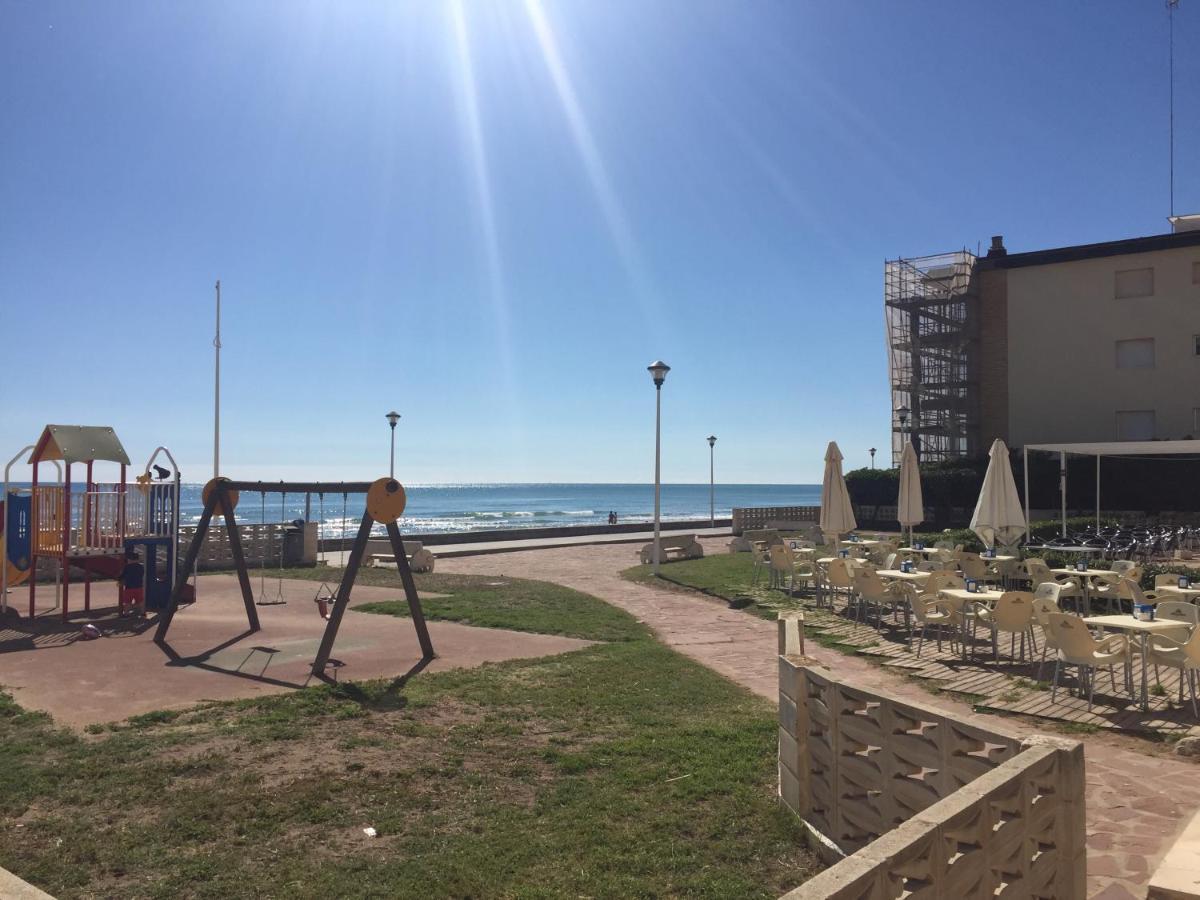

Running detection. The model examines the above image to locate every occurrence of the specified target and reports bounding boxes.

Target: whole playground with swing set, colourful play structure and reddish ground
[0,425,597,726]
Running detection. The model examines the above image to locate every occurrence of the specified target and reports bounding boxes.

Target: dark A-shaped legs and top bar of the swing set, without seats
[154,478,436,678]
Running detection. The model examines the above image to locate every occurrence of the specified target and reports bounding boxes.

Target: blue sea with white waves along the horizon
[180,484,821,539]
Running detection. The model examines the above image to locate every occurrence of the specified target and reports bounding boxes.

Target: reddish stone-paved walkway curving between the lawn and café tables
[438,540,1200,900]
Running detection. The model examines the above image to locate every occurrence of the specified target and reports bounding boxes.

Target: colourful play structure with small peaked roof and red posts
[0,425,180,620]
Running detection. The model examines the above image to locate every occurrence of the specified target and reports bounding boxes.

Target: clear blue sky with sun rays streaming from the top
[0,0,1200,484]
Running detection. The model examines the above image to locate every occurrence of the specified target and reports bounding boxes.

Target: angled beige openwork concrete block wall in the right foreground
[779,619,1086,900]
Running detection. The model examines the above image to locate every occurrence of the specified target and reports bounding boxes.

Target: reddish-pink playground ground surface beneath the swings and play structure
[0,575,590,727]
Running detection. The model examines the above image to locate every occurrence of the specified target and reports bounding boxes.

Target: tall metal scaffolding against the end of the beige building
[883,250,979,466]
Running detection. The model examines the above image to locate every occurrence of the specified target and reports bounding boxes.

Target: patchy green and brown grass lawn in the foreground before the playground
[0,572,818,899]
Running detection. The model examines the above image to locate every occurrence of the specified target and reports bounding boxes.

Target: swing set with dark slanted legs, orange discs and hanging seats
[155,478,434,678]
